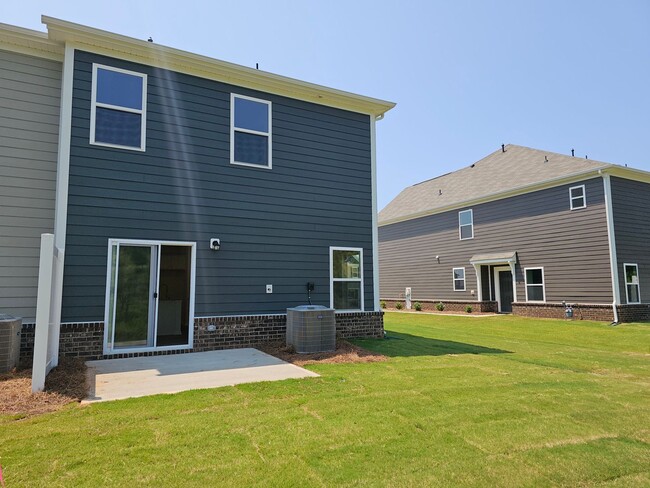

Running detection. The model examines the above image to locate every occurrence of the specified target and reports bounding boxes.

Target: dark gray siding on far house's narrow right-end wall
[611,177,650,303]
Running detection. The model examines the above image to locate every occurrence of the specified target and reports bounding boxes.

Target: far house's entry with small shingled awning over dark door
[469,251,517,313]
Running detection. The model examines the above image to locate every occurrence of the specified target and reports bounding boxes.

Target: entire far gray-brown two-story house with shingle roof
[379,145,650,321]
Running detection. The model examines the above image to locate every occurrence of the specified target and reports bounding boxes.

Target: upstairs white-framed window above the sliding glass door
[90,64,147,151]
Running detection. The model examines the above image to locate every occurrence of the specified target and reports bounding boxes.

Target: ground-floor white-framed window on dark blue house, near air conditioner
[330,247,363,310]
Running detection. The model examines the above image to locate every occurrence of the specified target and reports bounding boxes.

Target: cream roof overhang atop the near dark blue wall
[41,16,395,118]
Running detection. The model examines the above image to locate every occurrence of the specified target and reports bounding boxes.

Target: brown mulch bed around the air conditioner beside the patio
[256,339,388,366]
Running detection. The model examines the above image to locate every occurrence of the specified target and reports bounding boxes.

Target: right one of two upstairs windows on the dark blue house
[230,93,271,169]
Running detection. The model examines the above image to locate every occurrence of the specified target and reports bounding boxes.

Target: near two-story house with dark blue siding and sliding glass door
[0,17,394,358]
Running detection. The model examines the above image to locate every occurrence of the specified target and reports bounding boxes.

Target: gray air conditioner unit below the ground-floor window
[287,305,336,353]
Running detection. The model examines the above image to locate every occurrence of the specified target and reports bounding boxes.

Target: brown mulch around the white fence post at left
[0,358,88,419]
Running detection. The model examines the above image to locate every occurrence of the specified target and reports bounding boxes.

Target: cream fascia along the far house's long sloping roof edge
[379,168,605,227]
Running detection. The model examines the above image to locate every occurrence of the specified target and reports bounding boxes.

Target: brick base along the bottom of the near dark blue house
[20,312,384,368]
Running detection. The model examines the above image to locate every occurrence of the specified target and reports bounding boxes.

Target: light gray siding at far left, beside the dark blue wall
[0,51,62,322]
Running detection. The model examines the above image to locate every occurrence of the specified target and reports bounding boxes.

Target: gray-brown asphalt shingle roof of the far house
[378,144,614,225]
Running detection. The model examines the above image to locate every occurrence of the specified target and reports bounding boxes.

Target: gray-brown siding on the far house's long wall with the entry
[379,178,612,303]
